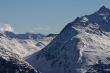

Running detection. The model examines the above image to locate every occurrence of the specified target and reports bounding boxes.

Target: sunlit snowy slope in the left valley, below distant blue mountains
[0,36,52,57]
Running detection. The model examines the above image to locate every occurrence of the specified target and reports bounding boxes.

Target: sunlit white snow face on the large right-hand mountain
[76,28,110,65]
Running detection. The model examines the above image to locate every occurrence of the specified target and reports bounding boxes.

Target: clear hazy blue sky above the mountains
[0,0,110,34]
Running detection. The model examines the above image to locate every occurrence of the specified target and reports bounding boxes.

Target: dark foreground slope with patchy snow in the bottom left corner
[0,47,39,73]
